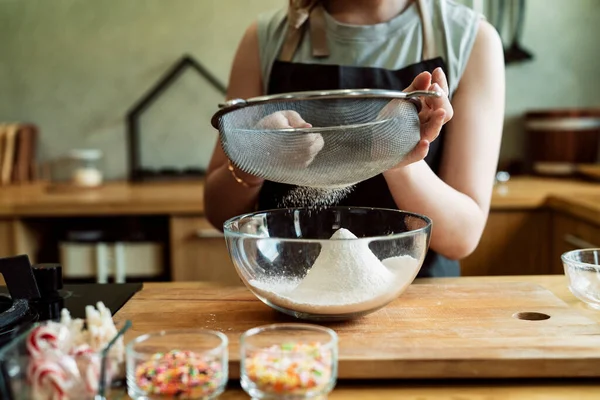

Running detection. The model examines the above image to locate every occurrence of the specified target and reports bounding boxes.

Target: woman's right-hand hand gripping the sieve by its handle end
[382,68,454,169]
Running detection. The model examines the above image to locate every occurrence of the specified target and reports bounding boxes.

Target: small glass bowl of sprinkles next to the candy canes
[126,329,229,400]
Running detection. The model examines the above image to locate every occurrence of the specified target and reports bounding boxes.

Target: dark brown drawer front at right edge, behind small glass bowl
[552,213,600,274]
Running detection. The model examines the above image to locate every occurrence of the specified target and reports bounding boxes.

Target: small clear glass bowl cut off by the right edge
[561,248,600,310]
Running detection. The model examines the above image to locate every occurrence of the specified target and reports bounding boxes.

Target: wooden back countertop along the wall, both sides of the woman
[0,177,600,220]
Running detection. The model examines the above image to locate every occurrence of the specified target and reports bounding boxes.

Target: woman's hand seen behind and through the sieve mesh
[255,110,325,168]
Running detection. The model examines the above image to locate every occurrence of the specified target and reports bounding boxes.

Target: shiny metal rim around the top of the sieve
[210,89,441,129]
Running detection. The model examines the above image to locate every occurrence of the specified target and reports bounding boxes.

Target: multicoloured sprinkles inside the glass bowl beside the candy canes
[135,350,223,399]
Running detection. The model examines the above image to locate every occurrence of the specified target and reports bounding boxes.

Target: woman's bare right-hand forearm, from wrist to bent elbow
[384,161,488,259]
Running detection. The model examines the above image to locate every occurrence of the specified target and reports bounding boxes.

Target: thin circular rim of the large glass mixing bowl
[223,206,433,243]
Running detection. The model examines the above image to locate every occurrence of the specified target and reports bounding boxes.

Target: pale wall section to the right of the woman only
[494,0,600,159]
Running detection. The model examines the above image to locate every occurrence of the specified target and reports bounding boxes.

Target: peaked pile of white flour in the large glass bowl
[248,228,419,314]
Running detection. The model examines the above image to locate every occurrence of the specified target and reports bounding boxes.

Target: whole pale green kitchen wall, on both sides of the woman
[0,0,600,177]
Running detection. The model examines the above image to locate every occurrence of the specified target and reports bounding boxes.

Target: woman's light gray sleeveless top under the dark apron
[257,0,483,97]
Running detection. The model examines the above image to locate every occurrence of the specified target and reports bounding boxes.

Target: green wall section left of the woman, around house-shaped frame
[0,0,286,177]
